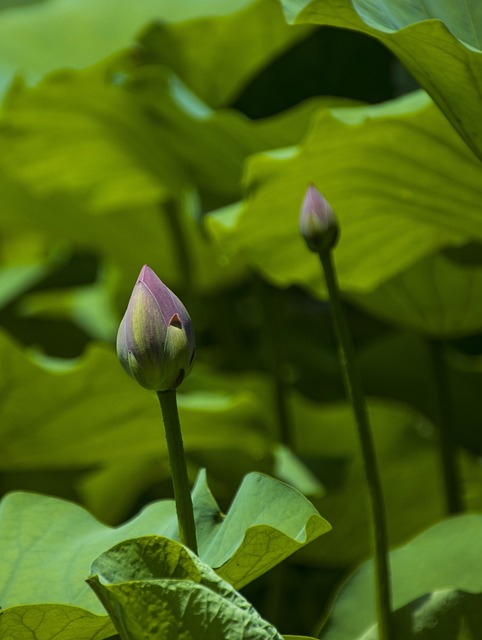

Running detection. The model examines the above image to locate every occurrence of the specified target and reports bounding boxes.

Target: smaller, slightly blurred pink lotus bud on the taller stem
[300,185,339,253]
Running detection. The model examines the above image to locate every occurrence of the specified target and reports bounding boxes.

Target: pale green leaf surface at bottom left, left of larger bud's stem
[0,493,176,615]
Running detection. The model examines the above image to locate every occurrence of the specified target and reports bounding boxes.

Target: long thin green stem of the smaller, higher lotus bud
[319,250,394,640]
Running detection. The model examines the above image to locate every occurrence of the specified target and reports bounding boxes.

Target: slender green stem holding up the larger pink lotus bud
[157,391,197,553]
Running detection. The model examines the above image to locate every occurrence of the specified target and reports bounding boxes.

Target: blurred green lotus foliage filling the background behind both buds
[0,0,482,633]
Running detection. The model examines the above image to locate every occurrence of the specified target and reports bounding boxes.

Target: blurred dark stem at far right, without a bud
[429,340,463,514]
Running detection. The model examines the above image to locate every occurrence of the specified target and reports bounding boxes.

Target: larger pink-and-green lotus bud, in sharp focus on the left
[117,265,195,391]
